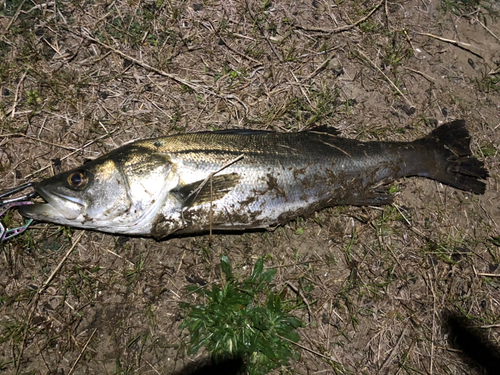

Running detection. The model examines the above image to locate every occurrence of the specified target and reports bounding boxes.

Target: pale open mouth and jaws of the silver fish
[19,185,85,222]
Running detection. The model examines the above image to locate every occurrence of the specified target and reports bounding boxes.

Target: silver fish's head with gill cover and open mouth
[19,147,176,235]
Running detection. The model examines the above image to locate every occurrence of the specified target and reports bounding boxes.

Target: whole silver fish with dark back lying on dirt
[19,120,489,240]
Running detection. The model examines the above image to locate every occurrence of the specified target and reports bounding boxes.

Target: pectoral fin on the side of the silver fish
[172,173,240,207]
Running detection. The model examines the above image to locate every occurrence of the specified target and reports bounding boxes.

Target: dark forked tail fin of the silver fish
[417,120,489,194]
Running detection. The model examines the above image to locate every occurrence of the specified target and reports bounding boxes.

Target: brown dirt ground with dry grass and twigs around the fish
[0,0,500,374]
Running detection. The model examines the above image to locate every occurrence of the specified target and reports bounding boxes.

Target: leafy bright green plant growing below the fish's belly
[181,256,303,374]
